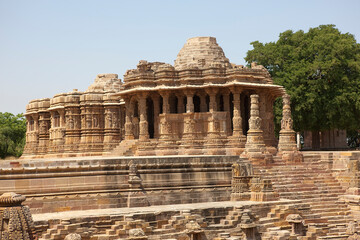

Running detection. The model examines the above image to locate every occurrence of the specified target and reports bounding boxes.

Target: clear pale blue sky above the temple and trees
[0,0,360,114]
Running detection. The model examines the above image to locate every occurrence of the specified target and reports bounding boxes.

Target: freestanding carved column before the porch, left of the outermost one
[241,94,272,165]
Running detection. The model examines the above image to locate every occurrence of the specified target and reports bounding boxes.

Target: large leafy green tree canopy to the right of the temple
[245,25,360,131]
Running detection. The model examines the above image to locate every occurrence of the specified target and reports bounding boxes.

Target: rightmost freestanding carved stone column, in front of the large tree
[278,94,303,162]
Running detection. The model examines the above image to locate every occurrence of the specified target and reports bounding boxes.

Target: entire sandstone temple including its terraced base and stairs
[4,37,360,240]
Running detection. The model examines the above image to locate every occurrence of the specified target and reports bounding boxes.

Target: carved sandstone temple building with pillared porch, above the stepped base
[23,37,293,158]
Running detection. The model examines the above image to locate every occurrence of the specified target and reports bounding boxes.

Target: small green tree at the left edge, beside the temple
[0,112,26,158]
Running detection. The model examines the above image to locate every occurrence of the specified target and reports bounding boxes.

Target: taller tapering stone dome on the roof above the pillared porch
[174,37,231,70]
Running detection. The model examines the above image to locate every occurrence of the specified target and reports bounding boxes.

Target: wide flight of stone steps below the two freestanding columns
[256,155,353,239]
